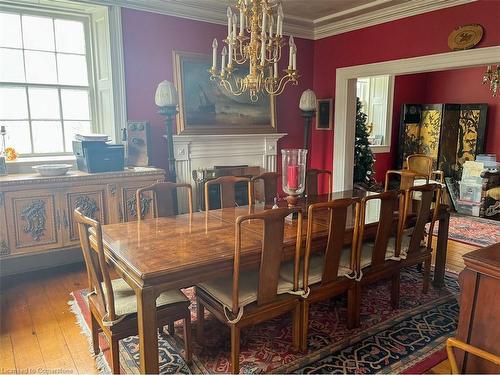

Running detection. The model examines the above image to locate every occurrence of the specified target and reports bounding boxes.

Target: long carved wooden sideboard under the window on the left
[0,167,165,276]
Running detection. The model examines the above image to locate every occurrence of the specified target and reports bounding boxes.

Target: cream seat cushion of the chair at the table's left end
[102,279,189,316]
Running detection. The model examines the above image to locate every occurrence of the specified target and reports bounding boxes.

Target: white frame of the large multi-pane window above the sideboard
[0,0,127,164]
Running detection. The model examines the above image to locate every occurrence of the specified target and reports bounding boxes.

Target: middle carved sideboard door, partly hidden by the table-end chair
[61,185,108,246]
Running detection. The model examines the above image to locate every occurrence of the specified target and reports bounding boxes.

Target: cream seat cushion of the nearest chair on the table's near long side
[196,270,293,307]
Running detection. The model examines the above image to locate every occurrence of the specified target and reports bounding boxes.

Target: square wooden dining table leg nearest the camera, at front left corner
[136,288,159,374]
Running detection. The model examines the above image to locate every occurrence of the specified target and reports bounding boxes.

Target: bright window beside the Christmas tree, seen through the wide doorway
[356,75,393,152]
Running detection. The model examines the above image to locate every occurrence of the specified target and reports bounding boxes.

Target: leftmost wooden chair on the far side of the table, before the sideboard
[135,182,193,220]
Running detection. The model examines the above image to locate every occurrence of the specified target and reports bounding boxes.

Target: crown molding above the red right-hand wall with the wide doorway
[314,0,476,40]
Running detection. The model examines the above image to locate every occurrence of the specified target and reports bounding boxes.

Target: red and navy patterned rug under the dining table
[70,270,458,374]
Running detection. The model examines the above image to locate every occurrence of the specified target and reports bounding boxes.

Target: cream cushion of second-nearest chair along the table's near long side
[280,248,351,288]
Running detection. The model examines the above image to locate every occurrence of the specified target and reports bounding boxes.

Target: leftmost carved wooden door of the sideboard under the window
[3,189,63,254]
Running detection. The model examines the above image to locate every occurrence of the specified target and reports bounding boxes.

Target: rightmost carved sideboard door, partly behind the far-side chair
[118,181,153,222]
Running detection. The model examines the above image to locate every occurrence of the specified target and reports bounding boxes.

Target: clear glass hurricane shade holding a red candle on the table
[281,149,307,195]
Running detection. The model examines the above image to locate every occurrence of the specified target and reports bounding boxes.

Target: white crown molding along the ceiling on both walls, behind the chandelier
[73,0,476,40]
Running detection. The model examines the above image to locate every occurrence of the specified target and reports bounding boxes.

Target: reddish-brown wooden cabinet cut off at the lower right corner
[455,243,500,374]
